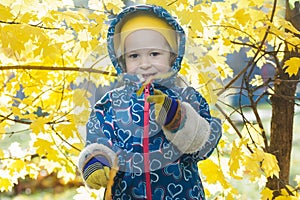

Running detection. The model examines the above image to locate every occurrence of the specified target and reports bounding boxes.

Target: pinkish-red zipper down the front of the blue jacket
[143,83,152,200]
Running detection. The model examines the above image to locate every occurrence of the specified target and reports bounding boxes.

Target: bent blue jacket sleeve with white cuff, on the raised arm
[164,87,221,160]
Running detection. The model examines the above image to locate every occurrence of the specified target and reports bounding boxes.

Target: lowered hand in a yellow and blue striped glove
[83,155,110,189]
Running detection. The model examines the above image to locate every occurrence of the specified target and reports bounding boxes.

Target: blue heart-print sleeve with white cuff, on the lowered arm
[78,93,116,172]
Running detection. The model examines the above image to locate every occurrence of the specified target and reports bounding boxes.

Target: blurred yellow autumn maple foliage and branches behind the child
[0,0,300,199]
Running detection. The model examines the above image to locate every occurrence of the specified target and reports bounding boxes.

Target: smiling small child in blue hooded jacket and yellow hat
[78,5,221,200]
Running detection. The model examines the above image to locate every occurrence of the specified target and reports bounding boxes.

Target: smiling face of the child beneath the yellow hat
[124,30,171,79]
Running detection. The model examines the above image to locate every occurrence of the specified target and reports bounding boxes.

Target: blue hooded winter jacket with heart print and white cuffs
[79,5,221,200]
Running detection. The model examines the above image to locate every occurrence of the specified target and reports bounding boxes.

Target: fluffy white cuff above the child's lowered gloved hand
[77,143,116,172]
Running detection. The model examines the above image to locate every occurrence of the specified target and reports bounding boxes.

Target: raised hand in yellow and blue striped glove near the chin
[147,90,180,129]
